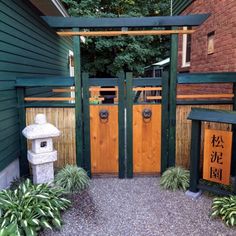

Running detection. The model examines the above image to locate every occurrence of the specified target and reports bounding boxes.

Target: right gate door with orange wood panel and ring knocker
[126,75,168,178]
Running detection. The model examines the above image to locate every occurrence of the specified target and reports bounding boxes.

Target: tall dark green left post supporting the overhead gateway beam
[73,28,84,167]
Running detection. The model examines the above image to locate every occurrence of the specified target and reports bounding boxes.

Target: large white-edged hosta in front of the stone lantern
[0,179,71,236]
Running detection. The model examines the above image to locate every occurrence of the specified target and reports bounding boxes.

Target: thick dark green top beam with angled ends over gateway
[42,14,210,29]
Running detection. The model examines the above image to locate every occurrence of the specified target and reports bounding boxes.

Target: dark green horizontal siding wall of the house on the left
[0,0,71,171]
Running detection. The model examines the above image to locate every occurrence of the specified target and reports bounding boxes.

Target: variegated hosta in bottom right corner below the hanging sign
[211,196,236,226]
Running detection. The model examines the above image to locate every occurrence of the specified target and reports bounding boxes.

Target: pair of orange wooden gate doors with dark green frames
[82,73,168,178]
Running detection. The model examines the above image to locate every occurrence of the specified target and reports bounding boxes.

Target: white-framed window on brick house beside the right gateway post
[182,27,192,67]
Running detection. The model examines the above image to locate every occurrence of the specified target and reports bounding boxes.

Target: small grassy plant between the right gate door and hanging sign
[160,167,190,191]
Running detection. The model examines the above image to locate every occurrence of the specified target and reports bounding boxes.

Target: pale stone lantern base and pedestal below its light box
[28,150,57,184]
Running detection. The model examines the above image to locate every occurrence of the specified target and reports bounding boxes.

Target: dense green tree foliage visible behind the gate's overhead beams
[63,0,170,76]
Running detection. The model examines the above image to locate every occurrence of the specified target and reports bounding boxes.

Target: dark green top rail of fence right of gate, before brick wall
[178,72,236,84]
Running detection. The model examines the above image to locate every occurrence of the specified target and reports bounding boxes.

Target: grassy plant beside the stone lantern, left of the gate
[55,165,89,193]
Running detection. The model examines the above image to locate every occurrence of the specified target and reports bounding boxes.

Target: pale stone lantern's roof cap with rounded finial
[22,114,61,139]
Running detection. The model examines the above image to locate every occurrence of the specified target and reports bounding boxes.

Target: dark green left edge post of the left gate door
[82,73,91,177]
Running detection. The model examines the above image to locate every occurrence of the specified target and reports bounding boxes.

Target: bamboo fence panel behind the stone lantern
[26,108,76,168]
